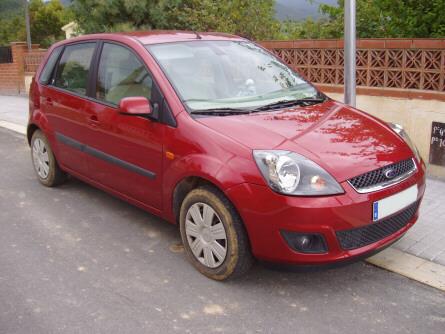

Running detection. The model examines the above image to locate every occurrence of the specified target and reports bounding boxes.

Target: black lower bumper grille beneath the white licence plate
[336,202,419,250]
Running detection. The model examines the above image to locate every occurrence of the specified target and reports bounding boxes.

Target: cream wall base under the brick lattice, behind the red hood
[328,93,445,180]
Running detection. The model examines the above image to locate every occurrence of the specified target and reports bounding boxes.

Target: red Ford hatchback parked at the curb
[28,31,425,280]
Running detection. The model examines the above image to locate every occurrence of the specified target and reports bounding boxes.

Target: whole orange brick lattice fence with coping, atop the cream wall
[260,39,445,101]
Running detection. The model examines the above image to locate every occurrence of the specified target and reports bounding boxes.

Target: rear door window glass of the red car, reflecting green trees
[54,43,96,95]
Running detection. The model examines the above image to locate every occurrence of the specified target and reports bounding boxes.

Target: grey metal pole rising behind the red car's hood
[345,0,357,107]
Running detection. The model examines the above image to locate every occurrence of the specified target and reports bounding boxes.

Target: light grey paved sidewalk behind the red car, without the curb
[0,96,445,284]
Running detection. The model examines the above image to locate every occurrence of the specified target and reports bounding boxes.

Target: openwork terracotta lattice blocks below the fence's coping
[262,40,445,92]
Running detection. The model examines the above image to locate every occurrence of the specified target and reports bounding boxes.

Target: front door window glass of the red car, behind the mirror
[96,43,153,105]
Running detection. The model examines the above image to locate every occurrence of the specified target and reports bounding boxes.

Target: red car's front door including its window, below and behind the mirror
[82,43,165,210]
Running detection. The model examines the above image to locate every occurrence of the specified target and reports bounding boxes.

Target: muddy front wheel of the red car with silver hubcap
[179,186,253,281]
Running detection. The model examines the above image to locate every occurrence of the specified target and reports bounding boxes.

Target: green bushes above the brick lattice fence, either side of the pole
[280,0,445,39]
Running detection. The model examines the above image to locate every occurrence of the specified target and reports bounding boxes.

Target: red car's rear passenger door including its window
[41,41,97,176]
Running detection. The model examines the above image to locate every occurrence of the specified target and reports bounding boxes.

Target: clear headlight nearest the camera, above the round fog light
[253,151,344,196]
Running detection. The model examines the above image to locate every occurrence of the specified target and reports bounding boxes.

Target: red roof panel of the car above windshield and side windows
[57,30,246,45]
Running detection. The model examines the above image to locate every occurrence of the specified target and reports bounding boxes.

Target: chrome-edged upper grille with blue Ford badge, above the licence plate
[349,159,416,191]
